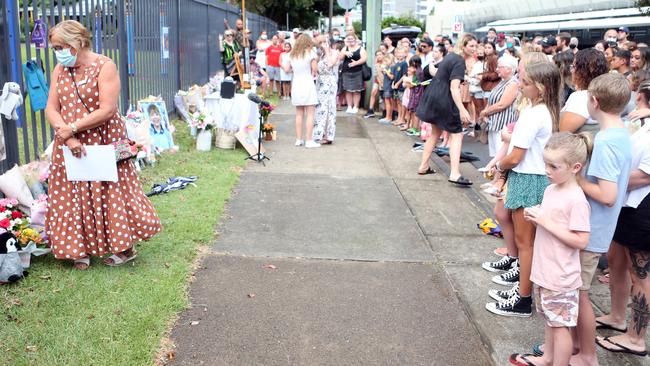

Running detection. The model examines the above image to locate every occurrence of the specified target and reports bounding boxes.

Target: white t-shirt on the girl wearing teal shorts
[508,104,553,175]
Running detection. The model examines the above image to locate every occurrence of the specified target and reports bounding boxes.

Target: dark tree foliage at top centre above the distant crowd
[236,0,345,28]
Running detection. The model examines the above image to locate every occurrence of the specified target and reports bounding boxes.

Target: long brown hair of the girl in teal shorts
[526,62,561,132]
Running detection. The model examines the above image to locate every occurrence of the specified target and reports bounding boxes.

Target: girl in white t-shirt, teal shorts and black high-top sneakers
[486,62,561,316]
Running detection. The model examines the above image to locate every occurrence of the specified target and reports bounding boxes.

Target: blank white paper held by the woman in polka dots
[63,145,117,182]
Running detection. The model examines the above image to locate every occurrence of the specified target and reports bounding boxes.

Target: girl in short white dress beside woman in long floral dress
[282,33,320,148]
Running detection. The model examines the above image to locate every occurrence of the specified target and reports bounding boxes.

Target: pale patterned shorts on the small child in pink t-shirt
[534,285,580,328]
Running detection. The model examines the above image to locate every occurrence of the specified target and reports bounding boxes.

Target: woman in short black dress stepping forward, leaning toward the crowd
[416,33,477,186]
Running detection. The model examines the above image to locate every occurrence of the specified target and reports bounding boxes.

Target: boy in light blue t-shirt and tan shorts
[571,74,632,365]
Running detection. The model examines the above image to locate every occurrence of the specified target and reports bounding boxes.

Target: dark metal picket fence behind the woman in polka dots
[0,0,277,172]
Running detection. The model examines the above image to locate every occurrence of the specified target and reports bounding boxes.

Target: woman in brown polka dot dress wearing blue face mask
[45,20,160,270]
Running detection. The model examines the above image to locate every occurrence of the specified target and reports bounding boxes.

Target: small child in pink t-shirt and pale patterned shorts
[510,132,591,365]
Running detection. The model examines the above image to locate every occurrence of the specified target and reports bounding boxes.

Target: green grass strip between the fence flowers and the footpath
[0,122,245,366]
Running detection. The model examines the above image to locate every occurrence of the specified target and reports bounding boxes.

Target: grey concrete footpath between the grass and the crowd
[171,102,650,365]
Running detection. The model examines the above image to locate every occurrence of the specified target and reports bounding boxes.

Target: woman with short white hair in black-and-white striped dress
[480,56,518,157]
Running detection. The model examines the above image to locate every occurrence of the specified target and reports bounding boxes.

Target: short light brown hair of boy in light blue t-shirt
[587,73,630,114]
